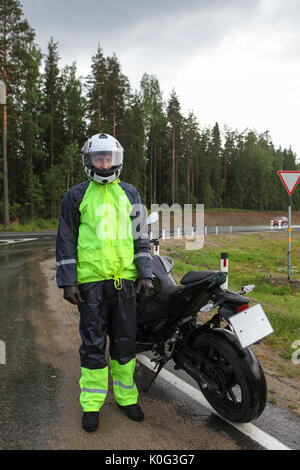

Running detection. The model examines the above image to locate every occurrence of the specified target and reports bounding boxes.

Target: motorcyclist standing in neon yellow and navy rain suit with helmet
[56,134,152,432]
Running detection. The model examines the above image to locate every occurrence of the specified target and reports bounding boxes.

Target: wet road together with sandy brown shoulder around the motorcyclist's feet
[0,235,299,450]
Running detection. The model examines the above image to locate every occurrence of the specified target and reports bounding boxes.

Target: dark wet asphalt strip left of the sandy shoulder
[0,241,59,449]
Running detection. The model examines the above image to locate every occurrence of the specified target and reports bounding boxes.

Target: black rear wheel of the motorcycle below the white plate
[193,330,267,423]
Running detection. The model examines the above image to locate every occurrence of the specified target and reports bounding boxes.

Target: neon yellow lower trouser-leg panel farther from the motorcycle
[79,366,108,411]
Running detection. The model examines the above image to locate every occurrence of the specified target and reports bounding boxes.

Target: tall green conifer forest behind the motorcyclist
[0,0,300,226]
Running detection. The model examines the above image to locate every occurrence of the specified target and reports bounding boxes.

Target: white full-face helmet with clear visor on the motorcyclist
[81,134,124,184]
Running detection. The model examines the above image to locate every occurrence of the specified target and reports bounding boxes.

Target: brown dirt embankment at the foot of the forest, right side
[204,209,300,226]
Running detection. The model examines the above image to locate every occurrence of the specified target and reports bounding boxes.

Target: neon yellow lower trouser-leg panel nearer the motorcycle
[110,358,138,406]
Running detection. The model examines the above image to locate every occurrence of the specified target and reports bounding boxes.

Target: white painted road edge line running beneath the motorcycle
[136,354,291,450]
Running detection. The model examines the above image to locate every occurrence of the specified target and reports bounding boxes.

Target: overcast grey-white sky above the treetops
[21,0,300,159]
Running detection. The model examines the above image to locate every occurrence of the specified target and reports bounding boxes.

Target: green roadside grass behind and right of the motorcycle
[161,232,300,377]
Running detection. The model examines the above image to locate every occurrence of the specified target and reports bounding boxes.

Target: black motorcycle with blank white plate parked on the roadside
[136,215,273,423]
